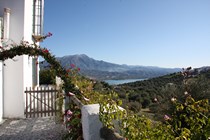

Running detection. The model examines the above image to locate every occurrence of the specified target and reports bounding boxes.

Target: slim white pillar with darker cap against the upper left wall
[4,8,11,39]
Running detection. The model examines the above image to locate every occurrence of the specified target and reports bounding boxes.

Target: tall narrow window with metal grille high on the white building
[33,0,44,36]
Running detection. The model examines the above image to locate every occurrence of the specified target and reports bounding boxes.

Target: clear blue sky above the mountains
[41,0,210,68]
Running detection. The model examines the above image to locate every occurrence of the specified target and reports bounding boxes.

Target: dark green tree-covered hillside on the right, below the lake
[114,67,210,116]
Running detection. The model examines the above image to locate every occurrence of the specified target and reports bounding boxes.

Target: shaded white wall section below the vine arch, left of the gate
[3,56,24,118]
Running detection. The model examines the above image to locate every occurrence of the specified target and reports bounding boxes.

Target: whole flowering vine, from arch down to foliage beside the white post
[0,33,101,139]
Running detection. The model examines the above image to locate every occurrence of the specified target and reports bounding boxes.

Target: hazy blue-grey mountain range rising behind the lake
[40,54,181,80]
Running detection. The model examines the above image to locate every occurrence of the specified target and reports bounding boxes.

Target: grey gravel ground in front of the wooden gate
[0,117,65,140]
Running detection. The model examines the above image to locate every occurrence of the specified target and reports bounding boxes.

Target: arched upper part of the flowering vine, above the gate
[0,33,75,93]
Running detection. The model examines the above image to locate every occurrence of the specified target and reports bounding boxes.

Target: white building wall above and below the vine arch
[0,0,33,118]
